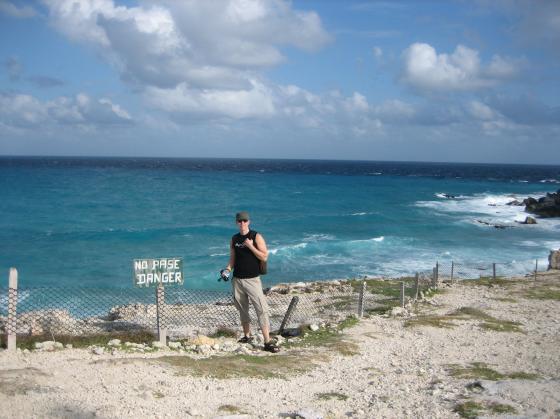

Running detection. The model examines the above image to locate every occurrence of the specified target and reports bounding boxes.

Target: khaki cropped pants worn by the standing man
[232,276,270,328]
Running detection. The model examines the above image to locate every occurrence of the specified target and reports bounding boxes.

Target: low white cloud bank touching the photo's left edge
[0,93,132,129]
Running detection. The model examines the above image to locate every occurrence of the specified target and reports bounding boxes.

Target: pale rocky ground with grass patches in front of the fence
[0,271,560,418]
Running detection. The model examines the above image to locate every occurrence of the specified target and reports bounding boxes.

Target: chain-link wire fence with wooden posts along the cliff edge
[0,262,539,346]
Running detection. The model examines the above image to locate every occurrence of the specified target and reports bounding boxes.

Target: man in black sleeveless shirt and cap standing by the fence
[220,211,279,353]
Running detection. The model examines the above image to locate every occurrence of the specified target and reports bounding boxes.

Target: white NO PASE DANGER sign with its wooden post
[133,258,184,345]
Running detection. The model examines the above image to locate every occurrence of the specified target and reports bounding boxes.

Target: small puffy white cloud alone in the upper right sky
[401,43,518,92]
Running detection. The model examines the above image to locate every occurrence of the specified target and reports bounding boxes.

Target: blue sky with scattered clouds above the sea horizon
[0,0,560,164]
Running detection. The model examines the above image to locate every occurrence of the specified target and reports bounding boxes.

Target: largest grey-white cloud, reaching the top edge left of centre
[42,0,330,119]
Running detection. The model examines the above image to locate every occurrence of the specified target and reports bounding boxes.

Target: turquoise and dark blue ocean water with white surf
[0,157,560,289]
